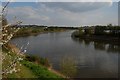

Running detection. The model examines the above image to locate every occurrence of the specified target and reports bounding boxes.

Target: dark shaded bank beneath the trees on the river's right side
[71,31,120,45]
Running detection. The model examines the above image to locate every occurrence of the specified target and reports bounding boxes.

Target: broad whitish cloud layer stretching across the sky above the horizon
[8,3,118,26]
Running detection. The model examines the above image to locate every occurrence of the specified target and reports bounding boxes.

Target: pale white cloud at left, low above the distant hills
[8,6,49,24]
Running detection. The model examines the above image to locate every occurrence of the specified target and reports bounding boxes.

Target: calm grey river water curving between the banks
[11,31,120,78]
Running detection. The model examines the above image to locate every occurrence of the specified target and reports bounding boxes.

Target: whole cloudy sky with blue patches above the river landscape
[2,0,118,26]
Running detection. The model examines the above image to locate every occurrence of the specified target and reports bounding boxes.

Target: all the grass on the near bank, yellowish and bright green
[2,44,63,80]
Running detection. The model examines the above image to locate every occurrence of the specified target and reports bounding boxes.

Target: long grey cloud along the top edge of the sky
[41,2,111,12]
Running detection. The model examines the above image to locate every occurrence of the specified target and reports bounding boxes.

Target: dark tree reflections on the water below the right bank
[72,38,120,53]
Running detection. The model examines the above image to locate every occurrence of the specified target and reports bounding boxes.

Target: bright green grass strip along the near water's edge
[21,60,64,80]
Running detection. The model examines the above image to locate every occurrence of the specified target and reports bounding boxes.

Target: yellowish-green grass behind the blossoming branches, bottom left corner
[2,47,37,78]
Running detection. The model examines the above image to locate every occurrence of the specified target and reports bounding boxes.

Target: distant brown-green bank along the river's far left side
[14,27,67,37]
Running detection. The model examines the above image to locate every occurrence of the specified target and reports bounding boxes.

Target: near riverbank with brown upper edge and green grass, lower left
[3,44,65,80]
